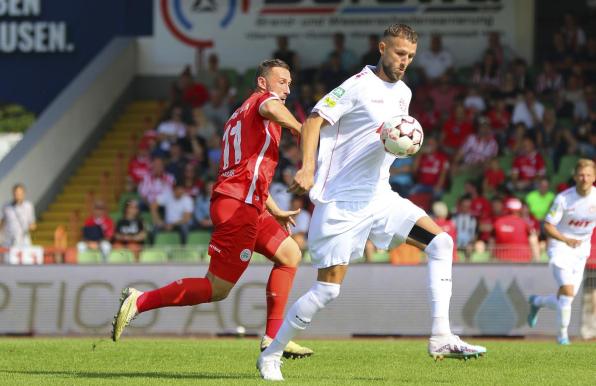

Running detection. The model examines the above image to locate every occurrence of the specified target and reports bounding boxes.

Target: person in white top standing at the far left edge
[0,184,37,248]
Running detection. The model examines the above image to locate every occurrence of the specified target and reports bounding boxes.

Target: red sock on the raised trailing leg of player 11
[137,278,213,313]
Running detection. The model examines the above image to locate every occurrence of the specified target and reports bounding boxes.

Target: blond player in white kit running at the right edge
[528,159,596,345]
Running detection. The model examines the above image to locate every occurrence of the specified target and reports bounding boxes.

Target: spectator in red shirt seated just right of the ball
[410,137,449,198]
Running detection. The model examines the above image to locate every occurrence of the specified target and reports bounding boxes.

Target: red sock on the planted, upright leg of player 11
[265,265,297,338]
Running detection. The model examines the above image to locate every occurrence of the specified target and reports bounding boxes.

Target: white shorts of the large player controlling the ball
[308,191,427,268]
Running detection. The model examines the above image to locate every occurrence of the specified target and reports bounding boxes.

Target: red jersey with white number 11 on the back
[213,92,281,211]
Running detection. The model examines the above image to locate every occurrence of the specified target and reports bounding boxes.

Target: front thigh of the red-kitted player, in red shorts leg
[255,212,301,267]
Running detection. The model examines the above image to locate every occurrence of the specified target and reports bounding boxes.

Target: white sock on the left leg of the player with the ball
[261,281,340,359]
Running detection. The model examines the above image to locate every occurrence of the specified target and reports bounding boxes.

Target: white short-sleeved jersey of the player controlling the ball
[310,66,412,203]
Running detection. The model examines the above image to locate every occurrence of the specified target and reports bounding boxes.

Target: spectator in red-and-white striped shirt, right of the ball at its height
[451,117,499,175]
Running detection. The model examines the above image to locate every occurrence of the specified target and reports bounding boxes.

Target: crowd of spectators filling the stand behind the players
[80,14,596,261]
